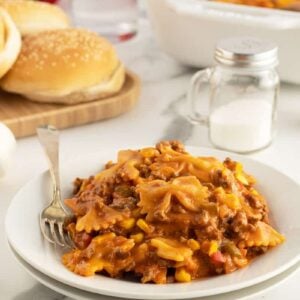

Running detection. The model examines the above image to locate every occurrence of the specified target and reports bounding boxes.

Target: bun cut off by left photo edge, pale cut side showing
[0,7,21,78]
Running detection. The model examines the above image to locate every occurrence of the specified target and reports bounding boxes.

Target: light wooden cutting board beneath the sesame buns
[0,71,140,137]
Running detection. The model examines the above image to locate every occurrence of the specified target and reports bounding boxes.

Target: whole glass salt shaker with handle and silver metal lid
[188,37,279,153]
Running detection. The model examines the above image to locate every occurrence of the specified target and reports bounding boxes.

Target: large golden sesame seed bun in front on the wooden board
[0,29,125,104]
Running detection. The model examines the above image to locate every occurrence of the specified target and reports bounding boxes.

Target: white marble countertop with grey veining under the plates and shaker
[0,24,300,300]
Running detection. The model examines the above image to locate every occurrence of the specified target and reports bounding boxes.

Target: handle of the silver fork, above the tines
[37,125,63,208]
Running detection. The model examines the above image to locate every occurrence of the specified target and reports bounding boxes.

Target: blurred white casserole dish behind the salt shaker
[147,0,300,84]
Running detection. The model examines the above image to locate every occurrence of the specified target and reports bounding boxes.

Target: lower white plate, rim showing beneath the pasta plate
[10,241,300,300]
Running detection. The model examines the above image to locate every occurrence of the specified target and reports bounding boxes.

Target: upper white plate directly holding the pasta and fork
[5,147,300,299]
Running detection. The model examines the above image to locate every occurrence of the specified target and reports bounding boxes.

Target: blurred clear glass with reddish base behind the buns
[72,0,139,42]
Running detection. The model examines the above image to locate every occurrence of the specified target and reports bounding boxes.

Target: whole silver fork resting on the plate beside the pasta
[37,125,74,248]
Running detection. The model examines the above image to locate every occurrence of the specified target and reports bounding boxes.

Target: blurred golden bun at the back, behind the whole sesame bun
[0,0,70,36]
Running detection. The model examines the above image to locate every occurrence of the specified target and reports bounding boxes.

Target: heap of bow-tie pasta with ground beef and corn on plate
[62,141,284,284]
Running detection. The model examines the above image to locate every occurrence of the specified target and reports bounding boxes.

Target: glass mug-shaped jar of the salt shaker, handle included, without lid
[189,65,279,153]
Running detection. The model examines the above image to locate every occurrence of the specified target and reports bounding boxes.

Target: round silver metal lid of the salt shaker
[215,37,278,68]
